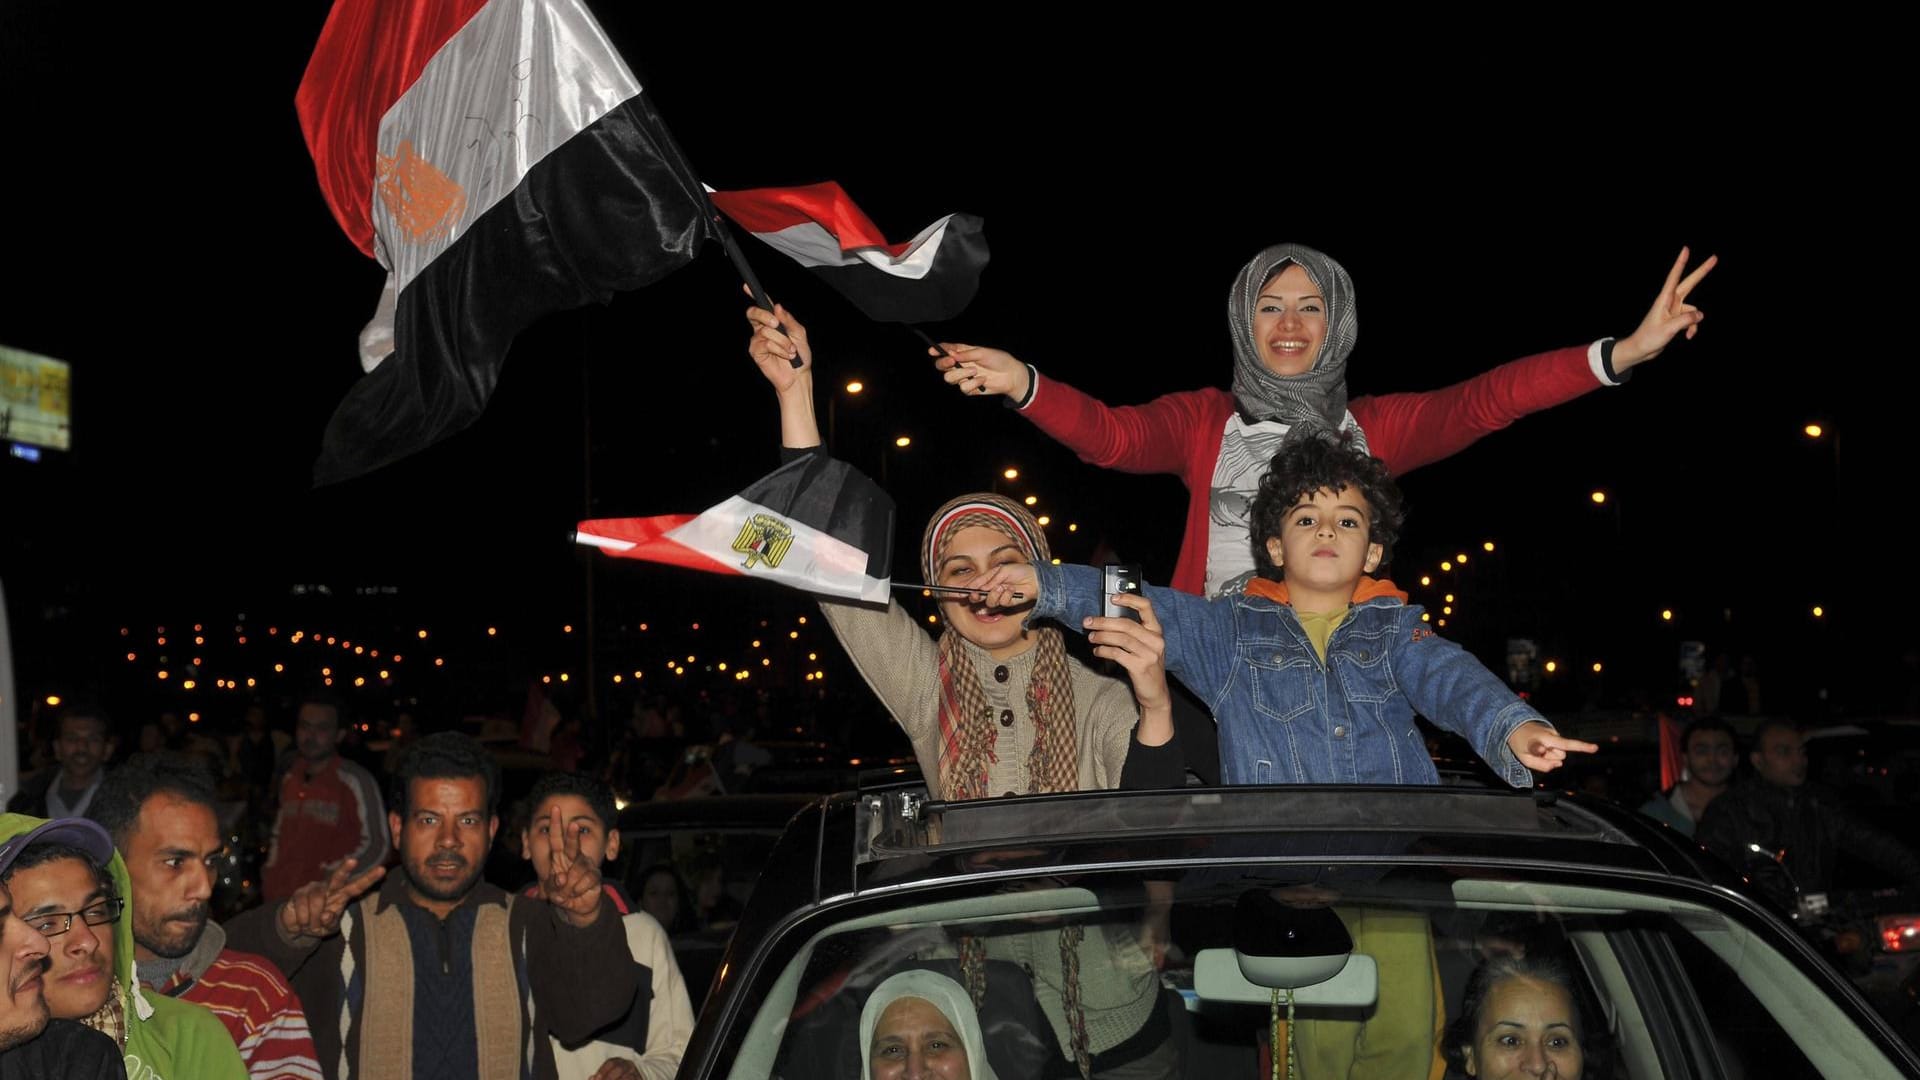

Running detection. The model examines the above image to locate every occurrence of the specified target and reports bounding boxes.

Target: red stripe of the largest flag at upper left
[294,0,488,256]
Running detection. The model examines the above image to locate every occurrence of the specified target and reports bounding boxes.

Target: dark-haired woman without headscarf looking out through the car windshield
[1442,953,1613,1080]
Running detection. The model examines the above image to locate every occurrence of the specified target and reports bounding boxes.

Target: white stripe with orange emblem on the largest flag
[371,0,639,292]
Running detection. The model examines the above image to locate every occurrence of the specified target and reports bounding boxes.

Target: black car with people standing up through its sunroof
[680,786,1920,1080]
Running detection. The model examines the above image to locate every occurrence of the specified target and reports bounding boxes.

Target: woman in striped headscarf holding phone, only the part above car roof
[747,297,1181,799]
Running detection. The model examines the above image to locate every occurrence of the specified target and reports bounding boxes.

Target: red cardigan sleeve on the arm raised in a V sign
[1348,346,1601,477]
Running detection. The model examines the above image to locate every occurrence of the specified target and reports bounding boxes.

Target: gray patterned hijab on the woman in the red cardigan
[1227,244,1367,452]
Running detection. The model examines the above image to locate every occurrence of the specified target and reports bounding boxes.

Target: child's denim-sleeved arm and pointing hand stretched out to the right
[1392,607,1599,788]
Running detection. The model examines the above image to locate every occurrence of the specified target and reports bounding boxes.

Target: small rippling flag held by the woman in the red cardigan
[710,181,987,323]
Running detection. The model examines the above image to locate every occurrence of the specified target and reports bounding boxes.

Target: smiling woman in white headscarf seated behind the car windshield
[860,969,996,1080]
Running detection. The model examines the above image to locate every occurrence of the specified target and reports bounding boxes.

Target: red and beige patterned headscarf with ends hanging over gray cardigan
[920,492,1079,799]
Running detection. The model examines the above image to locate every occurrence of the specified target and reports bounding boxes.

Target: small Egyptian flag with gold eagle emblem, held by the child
[574,454,893,603]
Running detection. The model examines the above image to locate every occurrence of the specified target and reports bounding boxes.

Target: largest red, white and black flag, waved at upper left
[296,0,714,484]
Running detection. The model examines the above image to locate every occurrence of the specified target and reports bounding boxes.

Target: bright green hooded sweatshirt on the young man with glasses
[0,813,248,1080]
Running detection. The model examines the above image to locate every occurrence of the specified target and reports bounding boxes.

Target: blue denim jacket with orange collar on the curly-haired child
[1031,563,1546,788]
